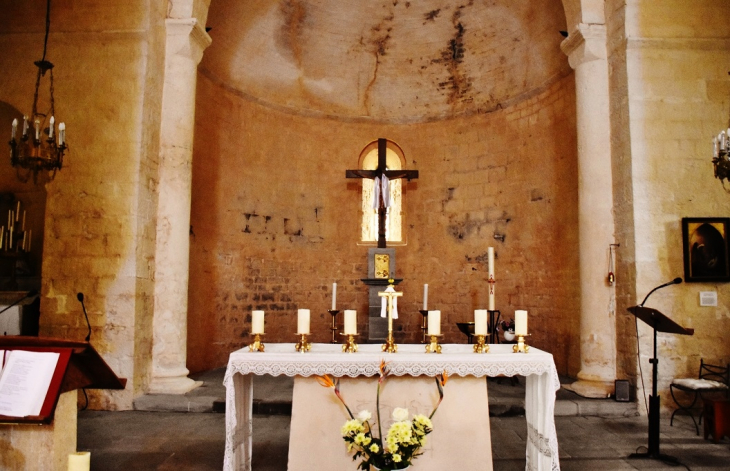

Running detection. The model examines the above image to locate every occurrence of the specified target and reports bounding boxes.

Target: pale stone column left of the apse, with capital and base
[149,18,211,394]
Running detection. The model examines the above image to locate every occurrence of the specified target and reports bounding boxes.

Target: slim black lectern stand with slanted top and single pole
[628,306,694,463]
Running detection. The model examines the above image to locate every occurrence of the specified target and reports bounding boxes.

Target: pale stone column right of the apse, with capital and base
[561,23,616,398]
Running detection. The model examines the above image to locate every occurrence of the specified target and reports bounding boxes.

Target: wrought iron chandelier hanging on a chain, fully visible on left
[10,0,68,182]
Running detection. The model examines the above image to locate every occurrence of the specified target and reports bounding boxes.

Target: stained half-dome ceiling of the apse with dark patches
[199,0,570,123]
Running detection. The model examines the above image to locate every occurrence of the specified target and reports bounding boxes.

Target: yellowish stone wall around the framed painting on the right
[613,0,730,406]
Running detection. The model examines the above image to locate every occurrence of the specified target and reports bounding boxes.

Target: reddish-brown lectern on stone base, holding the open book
[0,336,127,470]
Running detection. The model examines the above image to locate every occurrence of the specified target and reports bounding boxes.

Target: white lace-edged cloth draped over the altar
[223,343,560,471]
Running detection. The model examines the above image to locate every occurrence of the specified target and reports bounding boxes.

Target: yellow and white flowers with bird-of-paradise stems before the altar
[318,361,448,471]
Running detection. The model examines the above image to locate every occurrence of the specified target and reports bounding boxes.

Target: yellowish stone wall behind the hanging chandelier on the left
[0,0,165,409]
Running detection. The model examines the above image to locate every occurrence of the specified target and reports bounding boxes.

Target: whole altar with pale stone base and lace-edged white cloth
[223,343,560,471]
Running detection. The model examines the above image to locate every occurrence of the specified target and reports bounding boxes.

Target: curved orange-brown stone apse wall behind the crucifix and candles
[188,74,579,373]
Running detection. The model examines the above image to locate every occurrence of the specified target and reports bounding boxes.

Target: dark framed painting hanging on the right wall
[682,218,730,283]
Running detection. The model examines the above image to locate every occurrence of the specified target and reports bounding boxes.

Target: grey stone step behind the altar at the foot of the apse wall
[134,368,639,417]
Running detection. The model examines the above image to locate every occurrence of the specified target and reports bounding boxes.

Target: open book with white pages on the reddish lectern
[0,350,60,417]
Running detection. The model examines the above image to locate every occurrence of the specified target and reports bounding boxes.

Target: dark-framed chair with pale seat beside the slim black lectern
[669,359,730,435]
